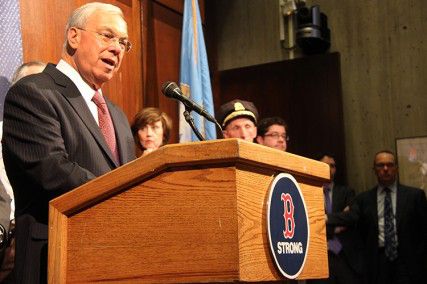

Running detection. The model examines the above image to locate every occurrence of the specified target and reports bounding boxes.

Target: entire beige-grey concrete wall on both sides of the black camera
[211,0,427,191]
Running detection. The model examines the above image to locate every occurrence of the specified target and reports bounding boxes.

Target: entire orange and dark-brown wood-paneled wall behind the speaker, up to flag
[20,0,204,142]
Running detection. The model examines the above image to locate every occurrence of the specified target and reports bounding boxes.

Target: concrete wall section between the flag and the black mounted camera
[210,0,286,70]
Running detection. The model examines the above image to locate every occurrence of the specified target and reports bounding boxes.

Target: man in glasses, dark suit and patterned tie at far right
[328,150,427,283]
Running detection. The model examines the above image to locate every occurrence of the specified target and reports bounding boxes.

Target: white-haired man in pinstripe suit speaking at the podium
[3,3,135,283]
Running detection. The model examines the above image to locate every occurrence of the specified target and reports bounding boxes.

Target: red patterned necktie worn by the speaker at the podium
[92,92,119,163]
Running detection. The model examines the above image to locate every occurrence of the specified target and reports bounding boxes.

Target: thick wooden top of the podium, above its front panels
[50,138,329,215]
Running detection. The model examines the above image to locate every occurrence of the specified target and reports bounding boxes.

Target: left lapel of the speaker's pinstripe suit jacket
[45,64,118,167]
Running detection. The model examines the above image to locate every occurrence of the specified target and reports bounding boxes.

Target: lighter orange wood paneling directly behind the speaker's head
[20,0,143,119]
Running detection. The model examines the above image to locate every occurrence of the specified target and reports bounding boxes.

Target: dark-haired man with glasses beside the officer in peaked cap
[256,116,289,151]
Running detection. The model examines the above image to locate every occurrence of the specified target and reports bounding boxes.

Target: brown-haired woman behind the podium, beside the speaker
[131,107,172,156]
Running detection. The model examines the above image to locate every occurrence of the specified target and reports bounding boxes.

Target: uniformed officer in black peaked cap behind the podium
[217,99,258,142]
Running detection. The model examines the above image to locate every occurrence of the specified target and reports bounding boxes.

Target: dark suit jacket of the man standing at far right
[328,184,427,283]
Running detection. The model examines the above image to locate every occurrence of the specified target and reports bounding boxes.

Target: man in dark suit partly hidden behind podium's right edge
[308,153,363,284]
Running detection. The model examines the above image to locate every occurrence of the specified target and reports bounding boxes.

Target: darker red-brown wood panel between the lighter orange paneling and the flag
[142,0,204,142]
